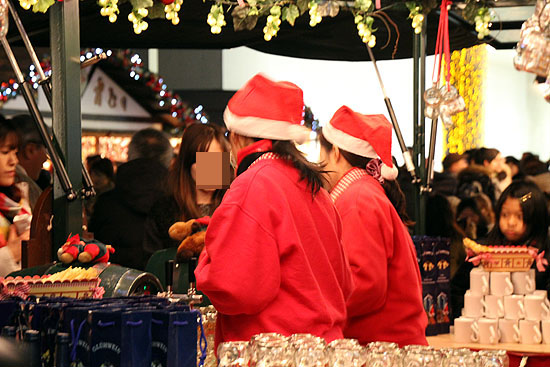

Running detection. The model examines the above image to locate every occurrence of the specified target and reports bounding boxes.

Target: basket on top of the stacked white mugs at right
[463,238,548,272]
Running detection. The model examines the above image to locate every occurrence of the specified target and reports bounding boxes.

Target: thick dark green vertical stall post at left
[50,0,82,251]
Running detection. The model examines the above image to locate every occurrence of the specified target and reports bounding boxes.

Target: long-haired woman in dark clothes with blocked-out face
[143,123,229,255]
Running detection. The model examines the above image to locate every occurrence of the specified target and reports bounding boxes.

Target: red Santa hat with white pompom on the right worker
[323,106,397,180]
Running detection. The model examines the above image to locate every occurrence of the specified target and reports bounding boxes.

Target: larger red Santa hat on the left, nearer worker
[223,74,310,144]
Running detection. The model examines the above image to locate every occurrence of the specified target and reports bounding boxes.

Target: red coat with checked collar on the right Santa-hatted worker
[331,168,428,346]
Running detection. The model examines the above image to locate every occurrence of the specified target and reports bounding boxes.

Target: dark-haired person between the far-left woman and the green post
[11,115,48,209]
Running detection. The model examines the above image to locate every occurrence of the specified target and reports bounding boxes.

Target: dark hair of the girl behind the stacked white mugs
[488,181,549,248]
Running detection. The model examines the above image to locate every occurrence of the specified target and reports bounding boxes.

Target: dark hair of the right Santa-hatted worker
[319,131,414,227]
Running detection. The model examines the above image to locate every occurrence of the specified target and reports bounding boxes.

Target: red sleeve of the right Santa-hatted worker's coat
[342,201,393,316]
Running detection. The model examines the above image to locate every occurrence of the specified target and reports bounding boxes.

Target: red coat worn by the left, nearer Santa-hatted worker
[195,157,352,348]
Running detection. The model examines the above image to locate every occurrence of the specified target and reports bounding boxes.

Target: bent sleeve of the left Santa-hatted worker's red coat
[195,204,281,315]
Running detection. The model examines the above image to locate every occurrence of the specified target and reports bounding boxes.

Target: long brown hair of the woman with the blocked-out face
[169,122,229,220]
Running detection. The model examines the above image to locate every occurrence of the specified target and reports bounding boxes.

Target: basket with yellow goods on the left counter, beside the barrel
[0,267,103,298]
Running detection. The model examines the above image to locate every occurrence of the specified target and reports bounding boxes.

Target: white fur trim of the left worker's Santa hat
[223,107,310,144]
